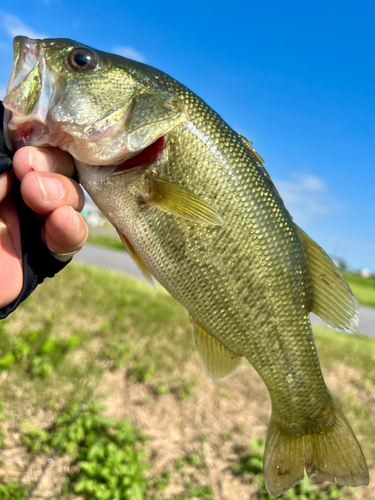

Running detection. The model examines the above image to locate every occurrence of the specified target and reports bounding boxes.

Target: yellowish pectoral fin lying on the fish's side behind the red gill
[147,177,223,225]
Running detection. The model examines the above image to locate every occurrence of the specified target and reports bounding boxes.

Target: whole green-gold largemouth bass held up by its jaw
[4,37,369,497]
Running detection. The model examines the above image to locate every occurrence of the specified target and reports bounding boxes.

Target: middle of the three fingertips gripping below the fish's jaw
[21,172,85,215]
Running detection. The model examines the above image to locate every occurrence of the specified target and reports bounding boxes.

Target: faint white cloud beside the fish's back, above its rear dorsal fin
[275,174,338,225]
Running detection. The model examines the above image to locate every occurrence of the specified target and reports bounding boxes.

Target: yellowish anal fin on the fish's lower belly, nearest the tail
[190,318,241,380]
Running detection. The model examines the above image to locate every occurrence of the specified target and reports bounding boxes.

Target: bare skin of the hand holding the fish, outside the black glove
[0,147,88,308]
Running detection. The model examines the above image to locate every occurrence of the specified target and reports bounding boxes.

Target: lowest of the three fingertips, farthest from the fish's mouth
[44,207,88,260]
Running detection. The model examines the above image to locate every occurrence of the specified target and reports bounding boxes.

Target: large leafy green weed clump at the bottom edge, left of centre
[22,403,148,500]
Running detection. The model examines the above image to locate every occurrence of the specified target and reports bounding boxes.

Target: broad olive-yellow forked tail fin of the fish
[264,398,369,497]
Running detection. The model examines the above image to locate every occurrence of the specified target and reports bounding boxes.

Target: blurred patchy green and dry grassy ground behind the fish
[0,264,375,500]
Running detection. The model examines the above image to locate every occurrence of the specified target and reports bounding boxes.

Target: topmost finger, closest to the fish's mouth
[13,146,75,181]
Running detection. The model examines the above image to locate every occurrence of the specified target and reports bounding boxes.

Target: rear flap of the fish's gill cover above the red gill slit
[125,89,188,151]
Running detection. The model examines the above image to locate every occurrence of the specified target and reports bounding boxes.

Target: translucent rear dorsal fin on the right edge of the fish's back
[297,227,358,333]
